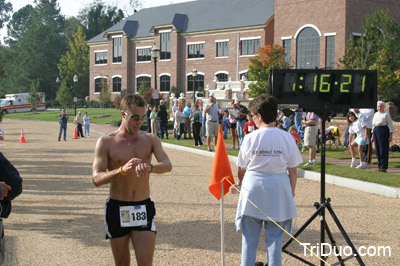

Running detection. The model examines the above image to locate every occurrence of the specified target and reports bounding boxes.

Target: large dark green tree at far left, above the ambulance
[0,0,67,100]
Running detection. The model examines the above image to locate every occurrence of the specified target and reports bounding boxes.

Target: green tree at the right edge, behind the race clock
[339,10,400,100]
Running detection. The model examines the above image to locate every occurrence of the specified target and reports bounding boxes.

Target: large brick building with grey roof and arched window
[88,0,400,103]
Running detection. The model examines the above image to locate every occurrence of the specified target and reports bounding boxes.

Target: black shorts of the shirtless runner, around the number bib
[104,198,156,239]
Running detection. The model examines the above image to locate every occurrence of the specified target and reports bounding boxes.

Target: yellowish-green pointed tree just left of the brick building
[58,26,89,99]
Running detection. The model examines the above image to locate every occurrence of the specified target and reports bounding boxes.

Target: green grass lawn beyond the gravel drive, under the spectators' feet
[5,108,400,187]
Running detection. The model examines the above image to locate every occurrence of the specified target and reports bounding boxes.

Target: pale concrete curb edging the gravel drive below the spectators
[162,143,400,199]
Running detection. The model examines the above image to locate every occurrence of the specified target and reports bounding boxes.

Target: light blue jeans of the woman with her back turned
[241,215,292,266]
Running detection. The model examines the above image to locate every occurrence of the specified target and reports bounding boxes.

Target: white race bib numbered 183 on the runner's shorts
[119,205,147,227]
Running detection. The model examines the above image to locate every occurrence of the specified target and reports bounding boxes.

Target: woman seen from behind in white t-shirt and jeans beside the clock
[236,94,303,266]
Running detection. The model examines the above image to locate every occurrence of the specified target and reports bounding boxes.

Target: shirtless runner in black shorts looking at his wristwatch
[93,94,172,266]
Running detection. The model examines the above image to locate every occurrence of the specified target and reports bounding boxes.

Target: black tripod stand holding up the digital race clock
[282,111,365,266]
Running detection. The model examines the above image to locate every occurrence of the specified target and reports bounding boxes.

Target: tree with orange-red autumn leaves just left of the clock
[248,44,290,97]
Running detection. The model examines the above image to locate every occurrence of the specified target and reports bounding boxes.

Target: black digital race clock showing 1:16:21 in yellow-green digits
[269,69,377,111]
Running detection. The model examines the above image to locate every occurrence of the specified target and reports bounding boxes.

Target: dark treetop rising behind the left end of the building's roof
[78,2,124,40]
